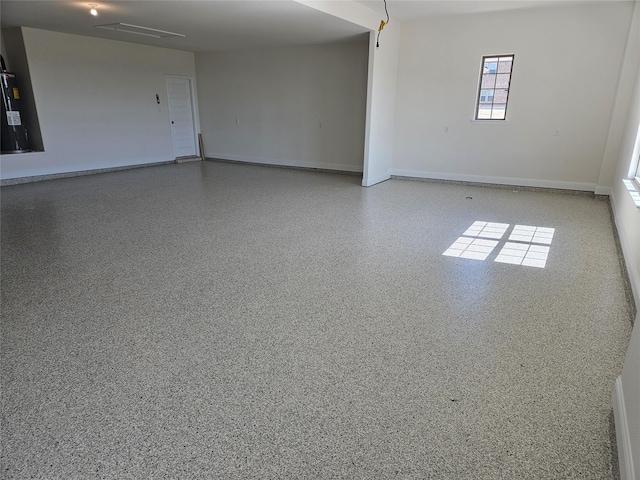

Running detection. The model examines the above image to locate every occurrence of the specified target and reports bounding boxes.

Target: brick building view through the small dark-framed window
[475,55,513,120]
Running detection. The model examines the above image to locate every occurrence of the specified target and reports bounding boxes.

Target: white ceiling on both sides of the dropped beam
[0,0,616,52]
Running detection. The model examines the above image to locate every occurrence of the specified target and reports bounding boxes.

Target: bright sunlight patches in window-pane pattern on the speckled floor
[443,221,555,268]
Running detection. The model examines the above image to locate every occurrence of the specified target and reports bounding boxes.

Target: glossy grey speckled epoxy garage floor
[0,162,631,480]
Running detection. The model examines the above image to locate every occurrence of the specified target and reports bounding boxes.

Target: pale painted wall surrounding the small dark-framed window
[393,2,633,190]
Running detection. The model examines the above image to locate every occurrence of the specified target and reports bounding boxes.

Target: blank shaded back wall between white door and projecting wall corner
[196,38,368,172]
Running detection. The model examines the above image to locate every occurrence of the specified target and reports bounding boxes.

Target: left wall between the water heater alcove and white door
[0,28,195,179]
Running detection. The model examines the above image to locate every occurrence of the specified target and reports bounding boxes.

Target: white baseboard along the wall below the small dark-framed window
[391,169,604,191]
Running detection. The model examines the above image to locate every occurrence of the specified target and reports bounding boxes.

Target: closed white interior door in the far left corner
[167,77,196,158]
